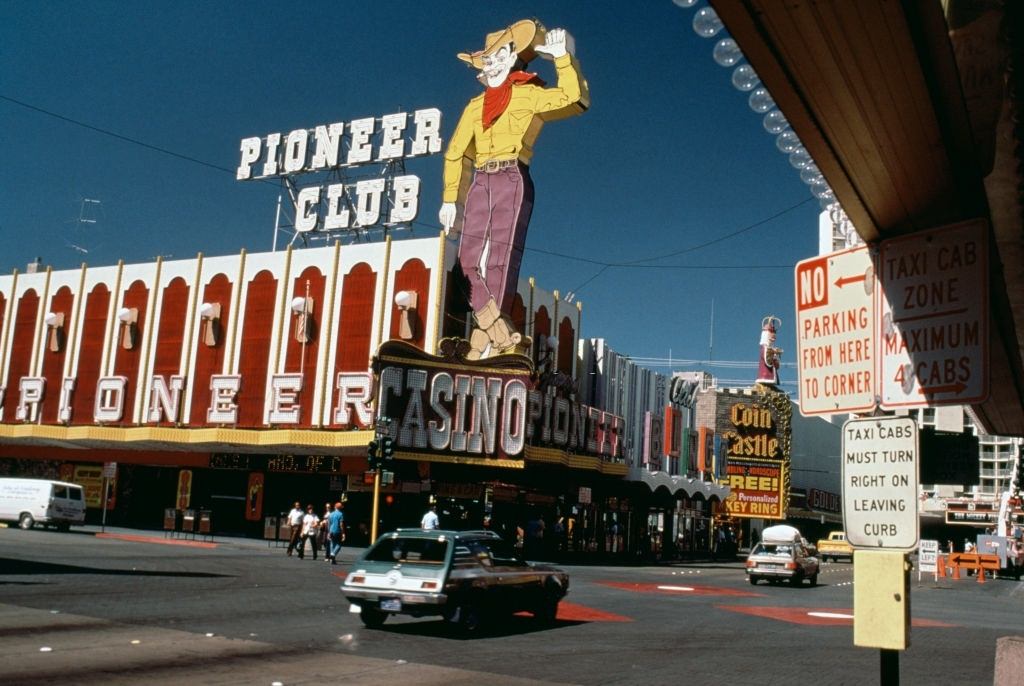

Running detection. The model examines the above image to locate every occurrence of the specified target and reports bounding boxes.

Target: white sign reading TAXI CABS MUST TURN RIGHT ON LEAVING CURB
[843,417,921,552]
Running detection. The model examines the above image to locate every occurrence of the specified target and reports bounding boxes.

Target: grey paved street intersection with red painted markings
[0,528,1024,686]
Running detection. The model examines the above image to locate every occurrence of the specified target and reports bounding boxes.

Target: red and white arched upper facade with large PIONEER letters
[0,238,598,454]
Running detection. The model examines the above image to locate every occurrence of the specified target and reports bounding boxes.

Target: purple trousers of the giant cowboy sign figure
[459,164,534,313]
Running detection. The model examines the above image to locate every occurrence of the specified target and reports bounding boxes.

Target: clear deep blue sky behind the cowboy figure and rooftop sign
[0,0,819,390]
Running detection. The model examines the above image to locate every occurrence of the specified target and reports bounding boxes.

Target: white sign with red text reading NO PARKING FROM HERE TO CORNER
[796,246,877,416]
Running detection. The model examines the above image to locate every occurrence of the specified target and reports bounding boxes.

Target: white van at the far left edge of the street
[0,478,85,531]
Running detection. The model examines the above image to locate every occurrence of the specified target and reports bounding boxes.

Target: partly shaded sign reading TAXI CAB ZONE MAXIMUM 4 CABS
[878,221,988,410]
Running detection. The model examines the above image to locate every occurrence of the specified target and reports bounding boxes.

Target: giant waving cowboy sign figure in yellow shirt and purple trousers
[438,19,590,359]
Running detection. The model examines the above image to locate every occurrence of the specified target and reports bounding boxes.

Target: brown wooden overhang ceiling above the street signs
[710,0,1024,436]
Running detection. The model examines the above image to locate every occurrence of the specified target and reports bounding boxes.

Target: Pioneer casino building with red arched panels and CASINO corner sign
[0,235,720,554]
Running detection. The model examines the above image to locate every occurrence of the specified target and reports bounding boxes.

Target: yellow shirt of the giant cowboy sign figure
[442,53,590,203]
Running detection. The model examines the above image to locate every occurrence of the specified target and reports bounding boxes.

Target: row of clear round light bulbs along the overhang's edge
[673,0,837,209]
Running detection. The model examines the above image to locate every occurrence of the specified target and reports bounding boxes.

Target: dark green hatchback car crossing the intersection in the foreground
[341,529,569,631]
